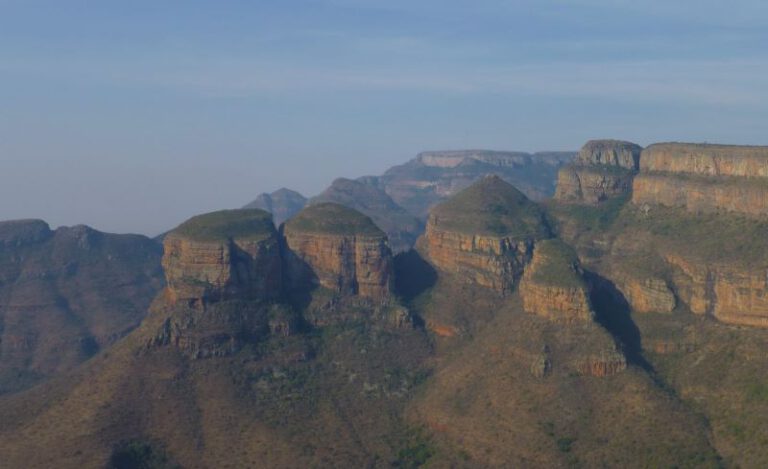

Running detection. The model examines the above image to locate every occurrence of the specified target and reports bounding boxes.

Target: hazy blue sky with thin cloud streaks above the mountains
[0,0,768,235]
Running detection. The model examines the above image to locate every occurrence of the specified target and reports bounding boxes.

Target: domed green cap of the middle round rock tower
[284,202,386,237]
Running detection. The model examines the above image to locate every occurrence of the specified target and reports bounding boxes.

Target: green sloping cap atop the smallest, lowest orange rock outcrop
[531,239,585,288]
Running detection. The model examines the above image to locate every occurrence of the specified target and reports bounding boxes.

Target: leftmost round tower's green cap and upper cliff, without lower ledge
[163,209,282,304]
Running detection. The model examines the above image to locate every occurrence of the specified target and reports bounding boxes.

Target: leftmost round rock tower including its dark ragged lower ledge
[147,209,284,358]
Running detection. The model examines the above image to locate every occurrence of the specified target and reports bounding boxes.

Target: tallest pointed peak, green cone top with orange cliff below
[424,176,549,294]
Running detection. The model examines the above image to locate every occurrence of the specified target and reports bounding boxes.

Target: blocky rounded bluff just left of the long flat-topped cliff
[555,140,642,204]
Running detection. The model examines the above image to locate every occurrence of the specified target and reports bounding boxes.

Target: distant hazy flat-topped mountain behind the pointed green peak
[372,150,575,218]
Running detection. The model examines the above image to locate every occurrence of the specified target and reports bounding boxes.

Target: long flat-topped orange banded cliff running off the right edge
[632,143,768,217]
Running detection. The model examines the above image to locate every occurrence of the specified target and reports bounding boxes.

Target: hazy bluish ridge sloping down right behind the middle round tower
[309,178,424,254]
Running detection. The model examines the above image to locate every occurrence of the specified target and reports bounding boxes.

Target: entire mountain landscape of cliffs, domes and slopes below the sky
[0,140,768,468]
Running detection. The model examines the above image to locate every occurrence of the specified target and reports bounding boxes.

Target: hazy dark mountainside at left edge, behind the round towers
[0,220,162,393]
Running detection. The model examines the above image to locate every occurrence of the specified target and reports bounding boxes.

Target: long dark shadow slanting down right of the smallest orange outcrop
[584,272,654,373]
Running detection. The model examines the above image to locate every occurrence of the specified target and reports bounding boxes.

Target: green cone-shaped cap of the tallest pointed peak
[432,176,550,238]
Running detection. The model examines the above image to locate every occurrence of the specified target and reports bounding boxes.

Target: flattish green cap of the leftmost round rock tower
[170,209,275,241]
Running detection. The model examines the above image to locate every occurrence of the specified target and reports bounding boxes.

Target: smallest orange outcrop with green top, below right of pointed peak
[520,240,594,323]
